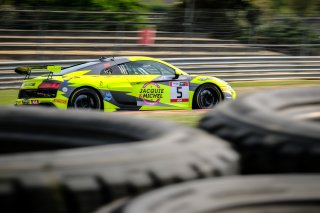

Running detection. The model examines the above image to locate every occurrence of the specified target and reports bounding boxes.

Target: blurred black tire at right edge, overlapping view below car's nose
[199,87,320,174]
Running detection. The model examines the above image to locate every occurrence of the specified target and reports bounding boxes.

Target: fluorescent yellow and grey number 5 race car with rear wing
[15,57,236,112]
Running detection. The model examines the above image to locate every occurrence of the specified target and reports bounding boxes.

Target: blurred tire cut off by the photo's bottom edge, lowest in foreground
[100,174,320,213]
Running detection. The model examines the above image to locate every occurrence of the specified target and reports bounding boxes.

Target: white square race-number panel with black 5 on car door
[170,81,189,102]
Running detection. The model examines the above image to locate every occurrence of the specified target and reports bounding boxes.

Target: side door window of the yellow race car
[122,61,175,75]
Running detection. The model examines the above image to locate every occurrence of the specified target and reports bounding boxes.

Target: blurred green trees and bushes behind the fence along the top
[0,0,320,55]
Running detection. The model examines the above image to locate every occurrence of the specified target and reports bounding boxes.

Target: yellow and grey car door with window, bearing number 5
[119,60,190,110]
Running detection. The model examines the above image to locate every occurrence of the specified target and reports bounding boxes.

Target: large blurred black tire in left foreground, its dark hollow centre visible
[0,108,238,213]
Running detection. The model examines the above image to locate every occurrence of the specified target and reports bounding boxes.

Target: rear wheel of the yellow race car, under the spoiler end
[68,87,103,110]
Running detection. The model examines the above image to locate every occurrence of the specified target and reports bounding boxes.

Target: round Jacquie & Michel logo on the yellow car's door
[139,82,164,106]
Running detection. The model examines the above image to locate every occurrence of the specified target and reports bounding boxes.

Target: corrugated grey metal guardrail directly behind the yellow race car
[0,56,320,89]
